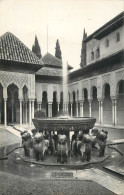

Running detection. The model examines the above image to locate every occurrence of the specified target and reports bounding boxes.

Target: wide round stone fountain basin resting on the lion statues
[32,116,96,133]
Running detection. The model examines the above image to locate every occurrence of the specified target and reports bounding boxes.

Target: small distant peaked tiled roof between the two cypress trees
[41,53,62,67]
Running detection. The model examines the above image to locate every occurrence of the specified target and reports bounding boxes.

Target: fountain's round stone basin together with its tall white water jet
[33,60,96,133]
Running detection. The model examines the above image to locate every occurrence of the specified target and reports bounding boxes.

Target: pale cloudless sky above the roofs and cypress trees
[0,0,124,70]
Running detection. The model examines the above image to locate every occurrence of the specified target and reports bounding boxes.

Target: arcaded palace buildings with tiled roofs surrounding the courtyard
[0,13,124,127]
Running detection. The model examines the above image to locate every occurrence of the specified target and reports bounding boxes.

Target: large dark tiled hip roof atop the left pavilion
[0,32,43,65]
